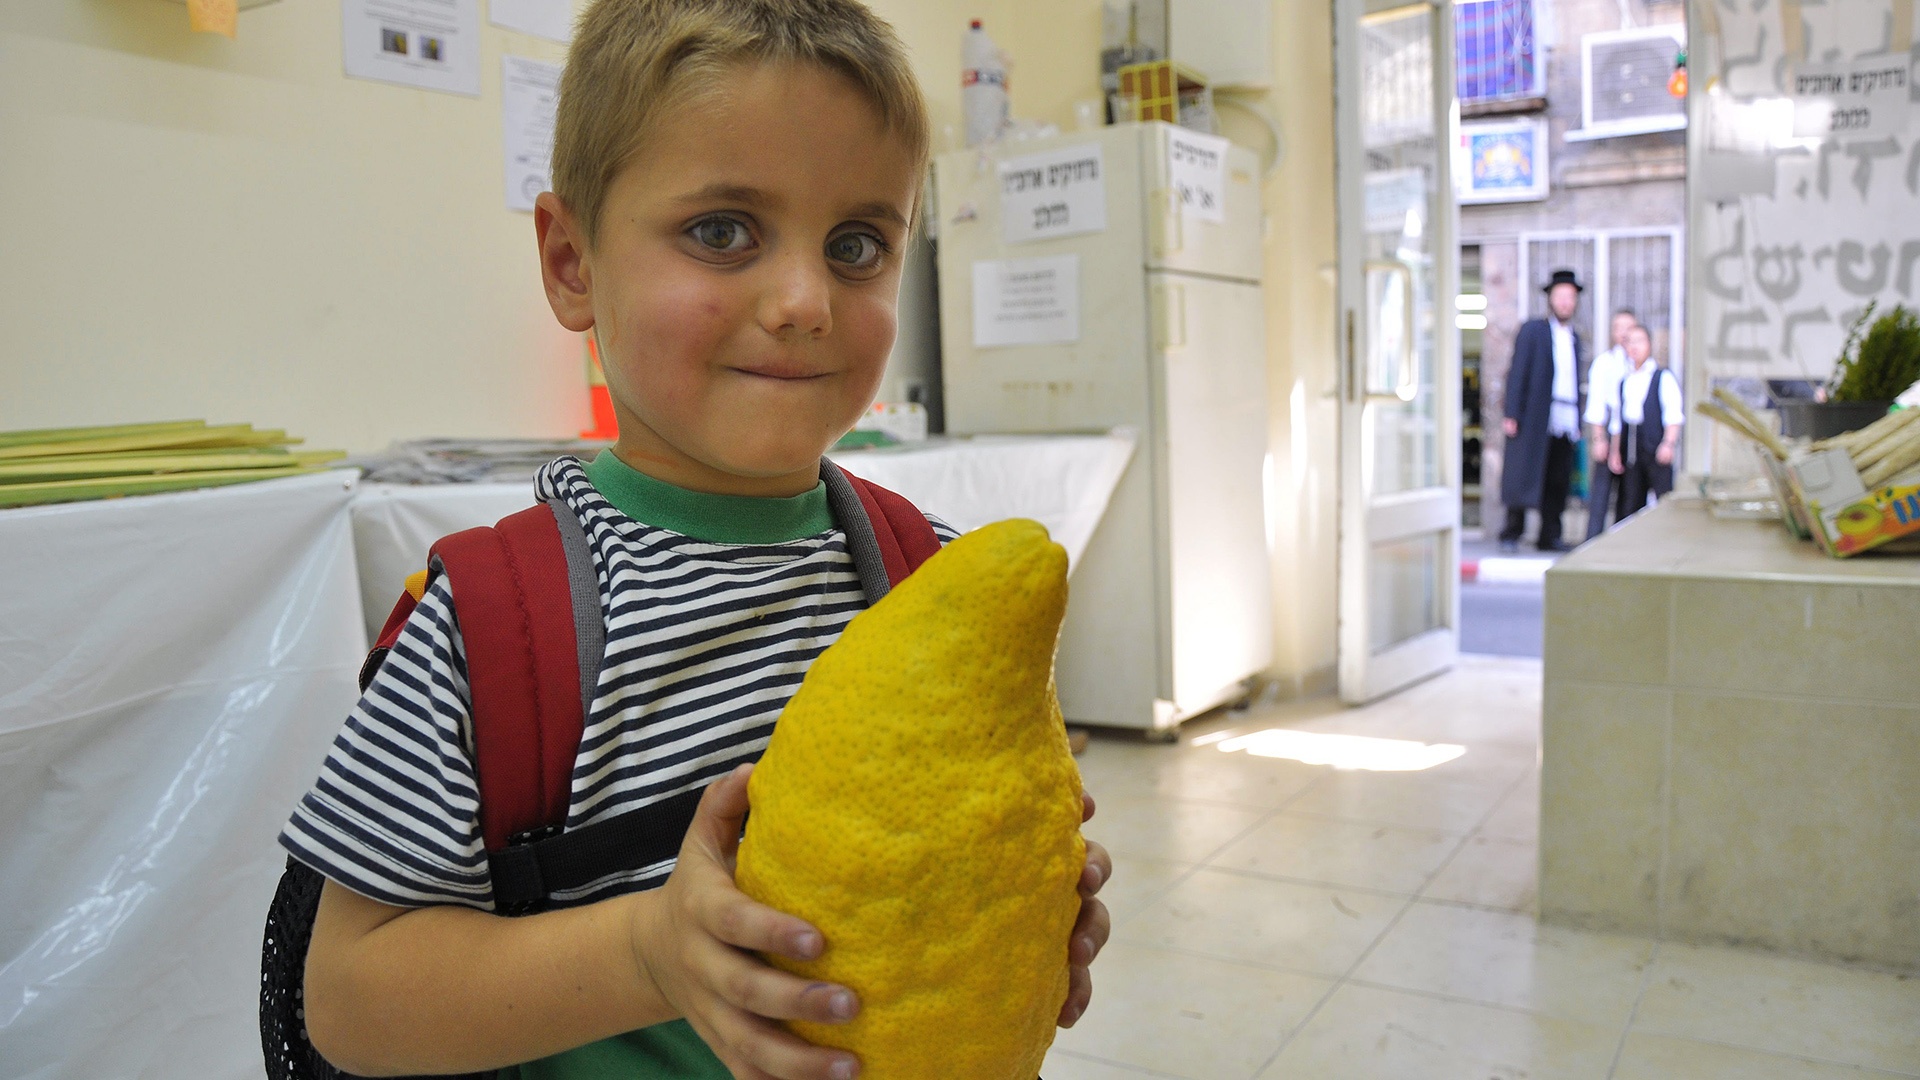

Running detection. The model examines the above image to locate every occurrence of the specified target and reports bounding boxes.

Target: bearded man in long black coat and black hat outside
[1500,269,1584,552]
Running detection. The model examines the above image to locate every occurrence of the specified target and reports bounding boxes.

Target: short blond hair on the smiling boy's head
[553,0,929,244]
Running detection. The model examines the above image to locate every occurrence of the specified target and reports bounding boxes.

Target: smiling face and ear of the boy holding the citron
[536,63,920,496]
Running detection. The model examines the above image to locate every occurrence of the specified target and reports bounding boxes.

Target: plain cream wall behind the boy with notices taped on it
[0,0,990,450]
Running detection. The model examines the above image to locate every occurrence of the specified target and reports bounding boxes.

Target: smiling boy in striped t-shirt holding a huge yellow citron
[282,0,1112,1080]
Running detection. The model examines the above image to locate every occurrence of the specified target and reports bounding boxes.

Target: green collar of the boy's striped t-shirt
[586,450,833,544]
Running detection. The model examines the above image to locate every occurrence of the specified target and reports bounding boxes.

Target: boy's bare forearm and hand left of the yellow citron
[305,767,858,1080]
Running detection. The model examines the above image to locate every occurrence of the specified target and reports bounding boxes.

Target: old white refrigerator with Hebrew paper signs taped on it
[933,123,1273,736]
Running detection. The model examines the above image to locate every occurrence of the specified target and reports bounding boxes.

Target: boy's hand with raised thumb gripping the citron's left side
[632,765,864,1080]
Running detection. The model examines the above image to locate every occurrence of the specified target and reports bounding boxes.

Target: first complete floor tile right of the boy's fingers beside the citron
[1116,869,1405,976]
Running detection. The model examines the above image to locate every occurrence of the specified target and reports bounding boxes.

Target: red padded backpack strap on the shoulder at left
[428,503,587,853]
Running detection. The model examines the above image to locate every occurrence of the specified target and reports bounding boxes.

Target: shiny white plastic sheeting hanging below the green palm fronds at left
[0,473,363,1080]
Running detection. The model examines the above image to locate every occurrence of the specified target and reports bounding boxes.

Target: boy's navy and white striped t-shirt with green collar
[280,454,954,909]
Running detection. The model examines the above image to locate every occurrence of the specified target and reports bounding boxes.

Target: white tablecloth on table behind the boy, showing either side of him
[353,430,1135,638]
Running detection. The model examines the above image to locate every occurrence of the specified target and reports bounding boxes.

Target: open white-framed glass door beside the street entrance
[1334,0,1459,703]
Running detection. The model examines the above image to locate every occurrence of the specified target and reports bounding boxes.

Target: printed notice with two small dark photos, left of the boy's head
[340,0,480,98]
